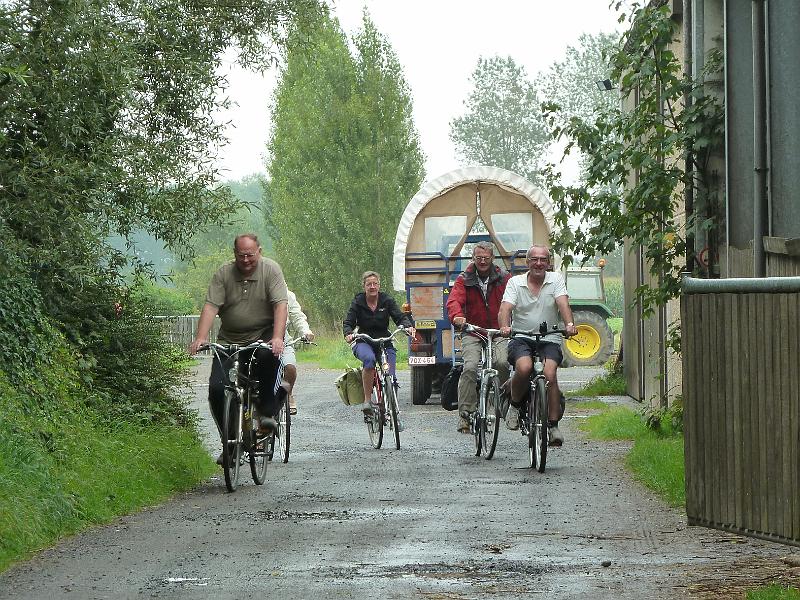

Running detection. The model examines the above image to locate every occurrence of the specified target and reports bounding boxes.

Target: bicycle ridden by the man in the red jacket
[462,323,503,460]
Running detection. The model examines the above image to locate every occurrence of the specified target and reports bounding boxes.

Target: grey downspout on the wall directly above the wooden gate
[752,0,769,277]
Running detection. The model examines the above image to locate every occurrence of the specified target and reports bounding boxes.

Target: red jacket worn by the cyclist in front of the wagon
[447,264,511,329]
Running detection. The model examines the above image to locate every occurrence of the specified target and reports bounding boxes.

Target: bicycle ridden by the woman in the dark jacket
[352,327,408,450]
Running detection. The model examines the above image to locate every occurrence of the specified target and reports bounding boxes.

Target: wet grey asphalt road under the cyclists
[0,361,791,600]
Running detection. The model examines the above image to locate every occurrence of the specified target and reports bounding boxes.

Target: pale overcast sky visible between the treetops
[214,0,620,179]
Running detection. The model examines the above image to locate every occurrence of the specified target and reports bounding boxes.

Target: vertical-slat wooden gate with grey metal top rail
[681,277,800,545]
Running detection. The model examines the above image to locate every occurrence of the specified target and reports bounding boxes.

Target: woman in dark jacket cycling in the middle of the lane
[342,271,414,413]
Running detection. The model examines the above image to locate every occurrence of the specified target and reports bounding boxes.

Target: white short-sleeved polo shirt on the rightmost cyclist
[503,271,567,344]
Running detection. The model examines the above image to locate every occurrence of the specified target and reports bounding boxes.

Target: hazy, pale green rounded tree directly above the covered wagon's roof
[450,56,548,182]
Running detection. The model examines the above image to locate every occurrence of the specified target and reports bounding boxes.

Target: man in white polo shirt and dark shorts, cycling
[498,245,577,446]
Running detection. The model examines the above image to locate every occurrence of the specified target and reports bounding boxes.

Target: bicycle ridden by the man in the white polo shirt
[511,323,567,473]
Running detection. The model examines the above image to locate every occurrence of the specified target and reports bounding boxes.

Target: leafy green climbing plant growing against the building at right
[546,3,723,330]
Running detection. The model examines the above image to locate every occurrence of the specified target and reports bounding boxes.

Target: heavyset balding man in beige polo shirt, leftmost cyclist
[189,233,288,462]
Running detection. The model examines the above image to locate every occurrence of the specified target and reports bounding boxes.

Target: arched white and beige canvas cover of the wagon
[392,166,554,291]
